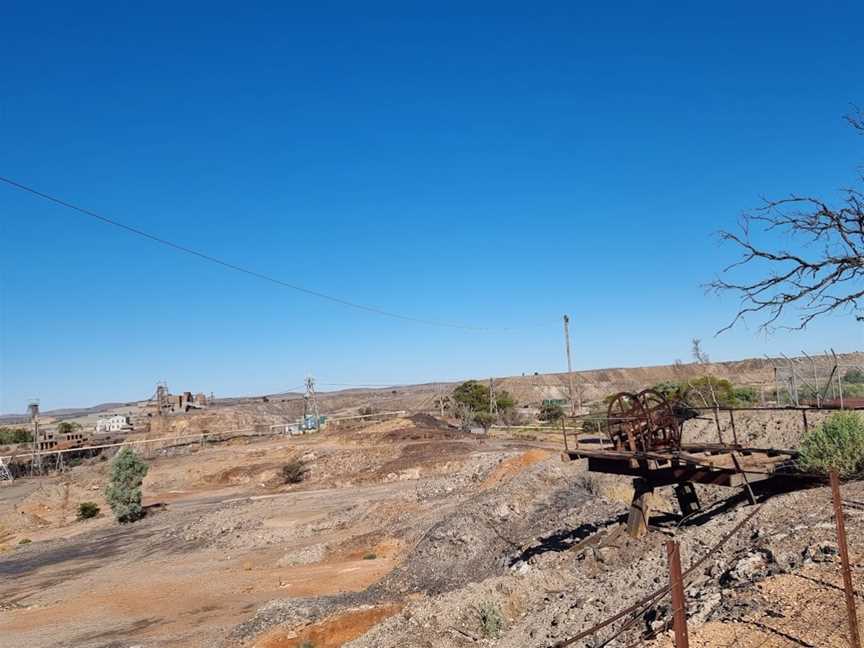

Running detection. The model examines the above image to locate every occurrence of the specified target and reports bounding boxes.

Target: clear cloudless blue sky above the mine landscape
[0,2,864,412]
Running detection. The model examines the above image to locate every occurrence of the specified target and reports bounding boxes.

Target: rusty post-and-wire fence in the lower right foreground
[549,474,864,648]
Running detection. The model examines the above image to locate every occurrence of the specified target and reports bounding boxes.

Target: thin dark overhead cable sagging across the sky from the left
[0,176,500,331]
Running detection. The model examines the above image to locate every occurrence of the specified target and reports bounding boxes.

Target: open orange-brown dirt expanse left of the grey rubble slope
[0,419,544,648]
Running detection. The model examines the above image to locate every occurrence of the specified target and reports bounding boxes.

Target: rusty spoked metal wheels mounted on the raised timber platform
[607,389,694,452]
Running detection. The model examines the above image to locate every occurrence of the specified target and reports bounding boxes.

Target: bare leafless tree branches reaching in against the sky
[708,109,864,333]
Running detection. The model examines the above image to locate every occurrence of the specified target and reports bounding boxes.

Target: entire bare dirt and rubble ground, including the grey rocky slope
[0,415,864,648]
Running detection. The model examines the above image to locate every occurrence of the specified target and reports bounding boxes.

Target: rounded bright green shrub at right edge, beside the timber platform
[798,412,864,477]
